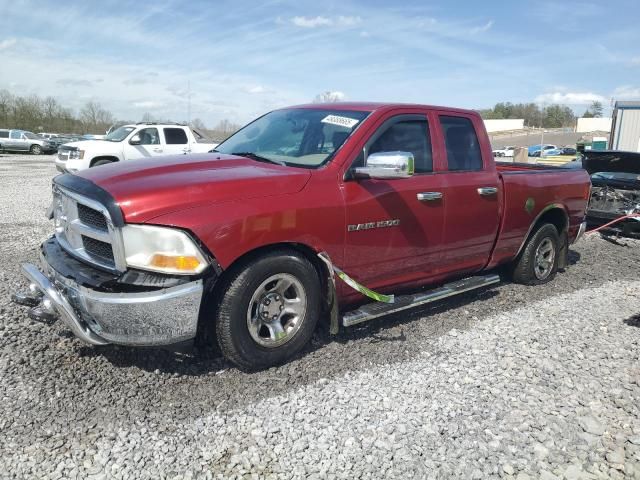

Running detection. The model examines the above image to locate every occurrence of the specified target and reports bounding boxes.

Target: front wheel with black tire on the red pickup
[216,250,321,371]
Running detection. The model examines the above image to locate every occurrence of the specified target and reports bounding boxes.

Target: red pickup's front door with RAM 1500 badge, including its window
[343,114,444,289]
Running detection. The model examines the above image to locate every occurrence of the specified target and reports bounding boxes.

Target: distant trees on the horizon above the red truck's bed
[479,102,603,128]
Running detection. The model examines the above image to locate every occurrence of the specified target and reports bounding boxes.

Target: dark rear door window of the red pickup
[440,115,482,171]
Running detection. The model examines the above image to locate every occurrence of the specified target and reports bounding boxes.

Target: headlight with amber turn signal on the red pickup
[122,225,208,275]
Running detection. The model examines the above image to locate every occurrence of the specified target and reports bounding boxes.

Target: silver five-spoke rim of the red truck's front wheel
[247,273,307,348]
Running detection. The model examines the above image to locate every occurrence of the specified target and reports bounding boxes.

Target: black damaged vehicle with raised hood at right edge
[576,150,640,238]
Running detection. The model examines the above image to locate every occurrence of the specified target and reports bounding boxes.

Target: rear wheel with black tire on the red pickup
[512,223,560,285]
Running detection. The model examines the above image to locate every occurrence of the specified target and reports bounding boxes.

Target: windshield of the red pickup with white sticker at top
[216,108,369,168]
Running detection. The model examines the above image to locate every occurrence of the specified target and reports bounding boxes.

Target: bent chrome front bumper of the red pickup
[16,251,203,346]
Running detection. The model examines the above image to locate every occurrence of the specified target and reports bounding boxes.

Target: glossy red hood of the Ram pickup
[78,153,311,223]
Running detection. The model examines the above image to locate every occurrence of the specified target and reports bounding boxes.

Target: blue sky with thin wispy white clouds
[0,0,640,126]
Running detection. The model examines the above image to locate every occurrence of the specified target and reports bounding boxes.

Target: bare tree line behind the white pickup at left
[0,89,240,142]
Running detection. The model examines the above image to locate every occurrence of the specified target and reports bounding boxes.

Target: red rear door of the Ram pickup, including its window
[434,112,501,273]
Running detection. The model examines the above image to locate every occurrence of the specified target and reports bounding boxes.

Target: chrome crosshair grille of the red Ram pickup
[53,185,126,271]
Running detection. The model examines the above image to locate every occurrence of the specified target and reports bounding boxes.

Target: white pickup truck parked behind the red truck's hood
[56,123,217,173]
